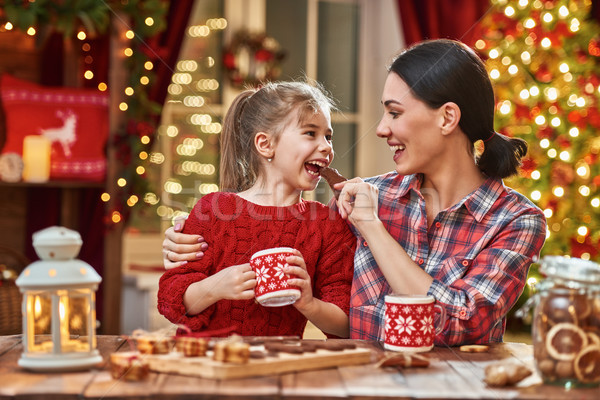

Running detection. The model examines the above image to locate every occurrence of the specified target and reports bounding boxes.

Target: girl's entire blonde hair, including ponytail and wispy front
[219,82,335,192]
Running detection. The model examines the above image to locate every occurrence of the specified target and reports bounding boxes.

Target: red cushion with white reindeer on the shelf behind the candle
[0,74,108,181]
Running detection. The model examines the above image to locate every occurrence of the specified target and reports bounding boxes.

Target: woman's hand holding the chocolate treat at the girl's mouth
[334,178,379,230]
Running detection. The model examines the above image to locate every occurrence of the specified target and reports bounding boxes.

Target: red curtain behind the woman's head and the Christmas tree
[397,0,600,46]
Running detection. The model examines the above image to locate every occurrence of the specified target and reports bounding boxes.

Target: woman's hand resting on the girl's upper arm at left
[162,218,208,269]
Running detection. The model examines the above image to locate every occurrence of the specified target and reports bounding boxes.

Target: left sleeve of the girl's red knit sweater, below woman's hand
[158,195,216,331]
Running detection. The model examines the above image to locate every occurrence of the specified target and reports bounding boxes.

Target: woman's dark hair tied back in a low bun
[388,39,527,178]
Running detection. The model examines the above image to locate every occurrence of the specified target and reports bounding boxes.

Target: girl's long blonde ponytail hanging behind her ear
[219,90,256,192]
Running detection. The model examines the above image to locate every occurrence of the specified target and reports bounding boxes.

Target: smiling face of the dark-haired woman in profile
[377,72,443,175]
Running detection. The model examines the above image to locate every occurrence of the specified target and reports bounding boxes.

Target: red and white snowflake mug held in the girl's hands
[250,247,300,307]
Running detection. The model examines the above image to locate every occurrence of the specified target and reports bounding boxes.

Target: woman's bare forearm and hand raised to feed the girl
[336,178,433,294]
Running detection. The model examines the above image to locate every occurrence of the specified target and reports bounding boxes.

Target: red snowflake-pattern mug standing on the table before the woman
[383,295,446,352]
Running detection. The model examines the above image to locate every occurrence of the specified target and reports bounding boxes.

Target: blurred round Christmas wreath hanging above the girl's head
[223,31,285,88]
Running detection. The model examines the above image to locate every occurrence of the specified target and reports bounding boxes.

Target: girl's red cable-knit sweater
[158,192,356,336]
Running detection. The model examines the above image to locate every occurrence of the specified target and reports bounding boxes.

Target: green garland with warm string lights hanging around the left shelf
[0,0,168,226]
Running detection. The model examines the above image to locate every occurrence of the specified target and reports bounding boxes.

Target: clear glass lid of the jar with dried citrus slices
[540,256,600,286]
